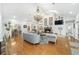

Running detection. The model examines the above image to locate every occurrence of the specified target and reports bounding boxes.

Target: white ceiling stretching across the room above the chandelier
[0,3,79,20]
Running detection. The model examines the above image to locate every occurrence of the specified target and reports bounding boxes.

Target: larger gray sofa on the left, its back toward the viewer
[23,33,41,44]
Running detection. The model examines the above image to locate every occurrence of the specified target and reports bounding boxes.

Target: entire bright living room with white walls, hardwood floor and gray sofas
[0,3,79,55]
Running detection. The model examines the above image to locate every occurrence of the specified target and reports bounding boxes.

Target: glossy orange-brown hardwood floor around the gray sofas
[6,35,71,55]
